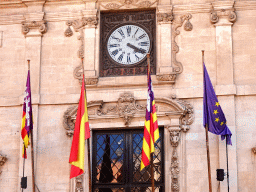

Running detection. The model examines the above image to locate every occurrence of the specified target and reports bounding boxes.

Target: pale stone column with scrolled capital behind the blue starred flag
[210,1,238,192]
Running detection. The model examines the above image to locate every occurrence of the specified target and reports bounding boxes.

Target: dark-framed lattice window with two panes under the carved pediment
[92,129,164,192]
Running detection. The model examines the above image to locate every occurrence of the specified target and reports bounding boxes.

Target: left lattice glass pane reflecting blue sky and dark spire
[96,134,124,183]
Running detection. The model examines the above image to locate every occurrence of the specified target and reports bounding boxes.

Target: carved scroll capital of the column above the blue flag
[210,4,237,24]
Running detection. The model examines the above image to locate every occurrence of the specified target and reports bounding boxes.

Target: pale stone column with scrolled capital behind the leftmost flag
[17,0,47,191]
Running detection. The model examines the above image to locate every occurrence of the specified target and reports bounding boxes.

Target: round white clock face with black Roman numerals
[107,25,150,65]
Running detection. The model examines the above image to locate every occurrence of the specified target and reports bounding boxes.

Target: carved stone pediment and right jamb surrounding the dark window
[63,92,194,192]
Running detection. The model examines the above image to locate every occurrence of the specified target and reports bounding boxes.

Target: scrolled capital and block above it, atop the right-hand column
[210,1,237,24]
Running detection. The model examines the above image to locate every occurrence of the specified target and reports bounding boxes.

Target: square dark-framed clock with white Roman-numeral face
[99,9,156,77]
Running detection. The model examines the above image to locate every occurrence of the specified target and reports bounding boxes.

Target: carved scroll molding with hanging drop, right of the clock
[172,13,193,74]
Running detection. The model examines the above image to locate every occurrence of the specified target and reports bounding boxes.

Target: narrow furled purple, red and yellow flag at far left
[21,70,33,158]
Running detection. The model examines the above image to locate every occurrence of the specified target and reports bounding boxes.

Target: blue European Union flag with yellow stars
[204,65,232,145]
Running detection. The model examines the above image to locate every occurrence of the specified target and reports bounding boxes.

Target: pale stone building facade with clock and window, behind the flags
[0,0,256,192]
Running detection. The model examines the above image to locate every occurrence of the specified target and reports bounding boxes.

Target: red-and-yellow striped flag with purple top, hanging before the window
[140,73,159,170]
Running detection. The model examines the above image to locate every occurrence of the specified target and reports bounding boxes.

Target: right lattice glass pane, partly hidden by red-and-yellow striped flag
[132,133,162,182]
